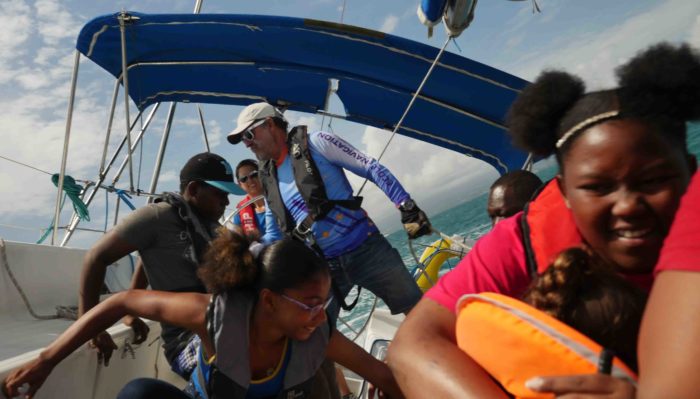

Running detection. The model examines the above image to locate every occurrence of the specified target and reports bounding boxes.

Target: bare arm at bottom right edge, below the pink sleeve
[637,270,700,399]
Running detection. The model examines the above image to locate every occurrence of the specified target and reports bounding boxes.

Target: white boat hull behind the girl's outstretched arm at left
[0,242,184,399]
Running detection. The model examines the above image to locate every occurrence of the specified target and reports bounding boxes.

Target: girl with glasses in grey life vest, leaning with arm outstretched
[3,229,402,399]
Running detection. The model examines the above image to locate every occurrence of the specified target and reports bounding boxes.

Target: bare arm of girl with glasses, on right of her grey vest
[327,331,403,398]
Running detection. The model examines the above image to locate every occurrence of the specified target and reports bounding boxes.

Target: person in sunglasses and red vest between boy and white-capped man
[233,159,265,239]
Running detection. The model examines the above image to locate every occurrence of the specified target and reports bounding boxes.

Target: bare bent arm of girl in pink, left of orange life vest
[387,298,507,399]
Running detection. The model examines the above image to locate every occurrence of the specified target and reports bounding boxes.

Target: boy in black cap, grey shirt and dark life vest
[79,152,245,379]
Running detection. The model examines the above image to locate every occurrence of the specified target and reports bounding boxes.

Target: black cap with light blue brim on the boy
[180,152,245,195]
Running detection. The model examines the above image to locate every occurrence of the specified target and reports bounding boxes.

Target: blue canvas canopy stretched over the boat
[76,12,527,173]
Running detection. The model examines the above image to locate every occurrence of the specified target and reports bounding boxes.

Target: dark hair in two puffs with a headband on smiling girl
[507,43,700,167]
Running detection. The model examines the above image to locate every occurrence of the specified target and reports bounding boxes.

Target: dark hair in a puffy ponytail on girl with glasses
[197,228,329,293]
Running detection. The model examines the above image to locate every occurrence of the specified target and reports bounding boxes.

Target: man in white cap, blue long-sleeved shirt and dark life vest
[228,102,431,316]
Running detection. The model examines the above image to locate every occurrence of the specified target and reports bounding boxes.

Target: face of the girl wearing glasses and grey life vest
[275,273,331,341]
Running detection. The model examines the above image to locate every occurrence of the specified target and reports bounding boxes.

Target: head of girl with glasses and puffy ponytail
[198,229,331,340]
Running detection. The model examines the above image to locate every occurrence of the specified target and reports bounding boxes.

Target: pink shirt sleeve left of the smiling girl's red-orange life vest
[425,212,532,311]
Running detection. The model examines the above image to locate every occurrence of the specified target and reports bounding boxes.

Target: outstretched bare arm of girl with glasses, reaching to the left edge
[3,290,213,397]
